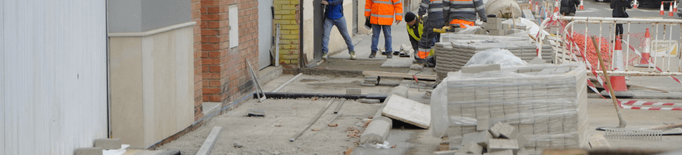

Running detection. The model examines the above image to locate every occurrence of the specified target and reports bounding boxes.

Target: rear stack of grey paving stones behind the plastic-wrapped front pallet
[435,35,554,82]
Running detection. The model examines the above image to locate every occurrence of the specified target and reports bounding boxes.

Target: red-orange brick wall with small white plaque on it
[201,0,259,106]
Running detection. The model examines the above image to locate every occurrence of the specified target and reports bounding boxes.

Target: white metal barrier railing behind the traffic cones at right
[538,13,682,76]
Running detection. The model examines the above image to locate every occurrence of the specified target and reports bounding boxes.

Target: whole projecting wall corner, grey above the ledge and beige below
[108,0,195,148]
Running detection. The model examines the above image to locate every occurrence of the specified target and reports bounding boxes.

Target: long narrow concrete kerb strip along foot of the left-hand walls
[146,90,256,150]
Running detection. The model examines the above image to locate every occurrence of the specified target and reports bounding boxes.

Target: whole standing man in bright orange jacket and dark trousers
[365,0,403,58]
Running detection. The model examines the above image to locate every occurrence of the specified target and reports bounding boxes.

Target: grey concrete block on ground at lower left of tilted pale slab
[360,117,393,144]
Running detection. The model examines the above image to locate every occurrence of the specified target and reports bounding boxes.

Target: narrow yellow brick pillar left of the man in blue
[273,0,300,65]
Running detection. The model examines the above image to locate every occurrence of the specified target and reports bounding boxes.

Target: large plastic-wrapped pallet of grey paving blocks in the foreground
[431,63,588,151]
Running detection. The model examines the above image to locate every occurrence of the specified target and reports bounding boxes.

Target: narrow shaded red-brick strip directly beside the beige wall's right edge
[192,0,204,121]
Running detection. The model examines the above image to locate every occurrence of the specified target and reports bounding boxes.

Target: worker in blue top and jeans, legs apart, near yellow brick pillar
[322,0,355,60]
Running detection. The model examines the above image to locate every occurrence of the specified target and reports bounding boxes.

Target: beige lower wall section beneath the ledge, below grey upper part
[110,25,194,148]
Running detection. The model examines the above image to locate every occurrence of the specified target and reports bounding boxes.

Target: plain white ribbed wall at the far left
[0,0,107,155]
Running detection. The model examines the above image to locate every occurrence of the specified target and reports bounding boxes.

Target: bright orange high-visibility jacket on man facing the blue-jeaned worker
[365,0,403,25]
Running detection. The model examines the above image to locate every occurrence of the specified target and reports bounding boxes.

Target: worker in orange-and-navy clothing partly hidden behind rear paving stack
[448,0,488,28]
